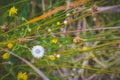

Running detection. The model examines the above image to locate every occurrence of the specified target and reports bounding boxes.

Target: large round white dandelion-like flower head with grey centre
[31,46,45,58]
